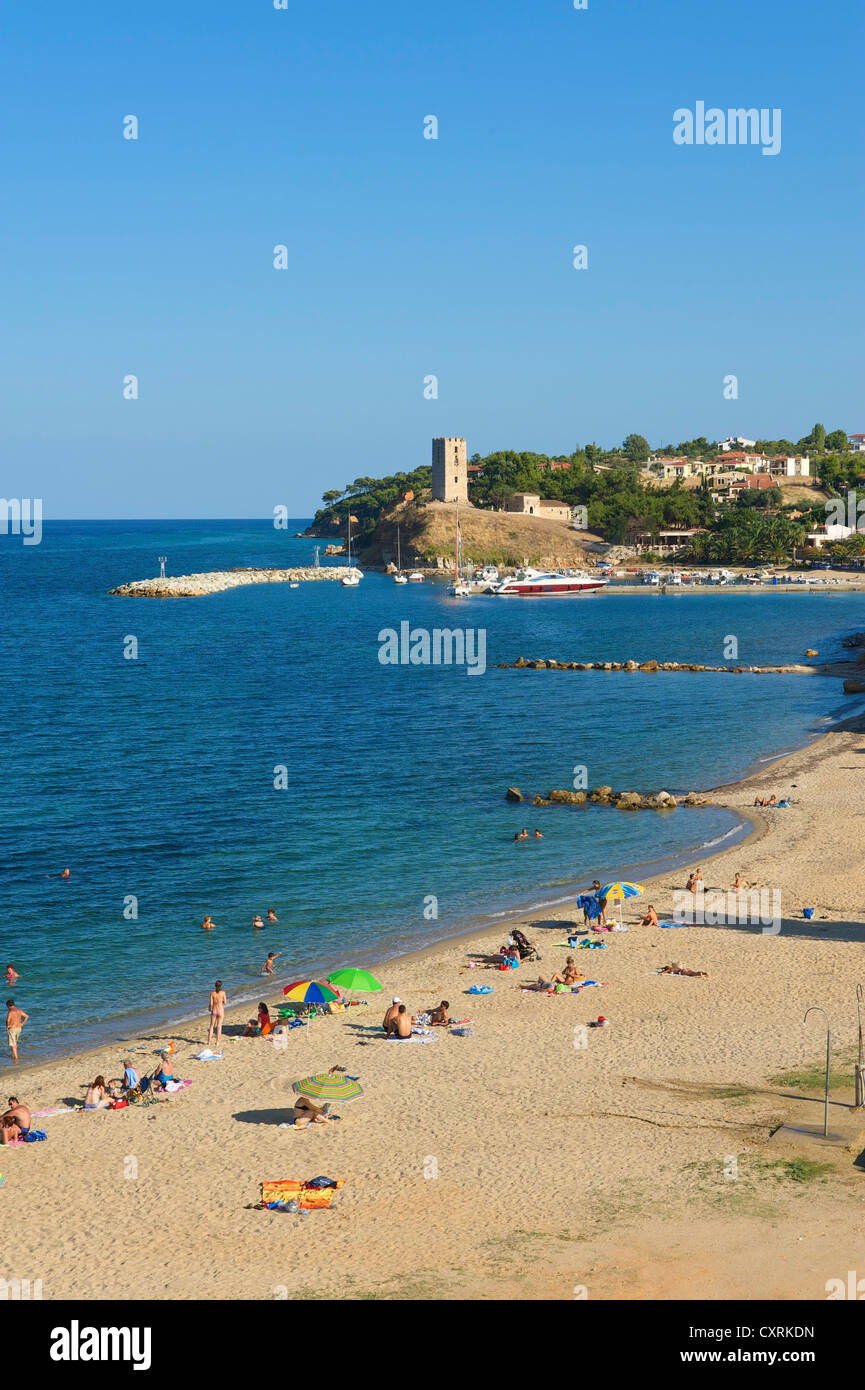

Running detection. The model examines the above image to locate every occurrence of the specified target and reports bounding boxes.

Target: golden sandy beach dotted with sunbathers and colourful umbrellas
[0,726,865,1300]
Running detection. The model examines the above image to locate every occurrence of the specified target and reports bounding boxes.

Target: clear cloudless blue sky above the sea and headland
[0,0,865,518]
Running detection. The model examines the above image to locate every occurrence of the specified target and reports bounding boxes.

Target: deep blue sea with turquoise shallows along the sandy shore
[0,521,862,1058]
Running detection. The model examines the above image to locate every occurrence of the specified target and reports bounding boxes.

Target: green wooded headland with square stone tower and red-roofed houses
[307,425,865,566]
